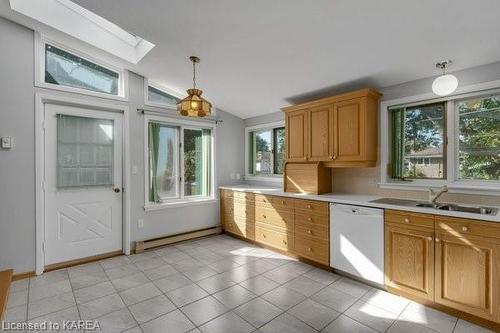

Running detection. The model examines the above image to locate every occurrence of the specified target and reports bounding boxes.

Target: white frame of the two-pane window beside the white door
[143,114,217,211]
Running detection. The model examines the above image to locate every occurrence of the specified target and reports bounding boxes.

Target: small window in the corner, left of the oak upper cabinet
[247,126,285,176]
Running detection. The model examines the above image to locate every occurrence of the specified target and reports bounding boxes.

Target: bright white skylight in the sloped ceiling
[10,0,155,64]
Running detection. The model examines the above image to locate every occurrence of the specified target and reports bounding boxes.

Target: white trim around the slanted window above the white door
[34,33,128,101]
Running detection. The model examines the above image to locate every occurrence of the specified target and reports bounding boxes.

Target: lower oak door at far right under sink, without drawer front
[435,233,500,320]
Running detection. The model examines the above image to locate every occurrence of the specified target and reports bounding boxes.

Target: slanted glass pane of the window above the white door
[44,44,121,96]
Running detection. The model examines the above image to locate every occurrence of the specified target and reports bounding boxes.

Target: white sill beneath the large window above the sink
[378,180,500,196]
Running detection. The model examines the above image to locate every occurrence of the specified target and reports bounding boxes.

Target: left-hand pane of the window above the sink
[389,103,446,179]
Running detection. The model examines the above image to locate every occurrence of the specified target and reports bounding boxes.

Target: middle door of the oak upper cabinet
[308,105,333,161]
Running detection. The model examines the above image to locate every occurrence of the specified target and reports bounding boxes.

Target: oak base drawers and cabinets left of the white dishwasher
[220,190,330,266]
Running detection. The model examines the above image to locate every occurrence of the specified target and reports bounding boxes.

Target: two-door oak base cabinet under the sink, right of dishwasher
[385,210,500,323]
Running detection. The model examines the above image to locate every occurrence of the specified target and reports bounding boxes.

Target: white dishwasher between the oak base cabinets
[330,203,384,285]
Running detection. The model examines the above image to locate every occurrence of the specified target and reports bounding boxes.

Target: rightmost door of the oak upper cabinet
[332,99,364,162]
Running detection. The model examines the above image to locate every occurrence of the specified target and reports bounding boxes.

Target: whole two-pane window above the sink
[388,94,500,184]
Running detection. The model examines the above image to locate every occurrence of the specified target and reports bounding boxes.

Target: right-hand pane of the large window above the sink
[455,96,500,181]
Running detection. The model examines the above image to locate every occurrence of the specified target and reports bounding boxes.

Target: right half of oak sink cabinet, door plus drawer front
[435,217,500,322]
